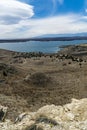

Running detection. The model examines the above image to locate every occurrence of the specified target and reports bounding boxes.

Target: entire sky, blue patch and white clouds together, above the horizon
[0,0,87,39]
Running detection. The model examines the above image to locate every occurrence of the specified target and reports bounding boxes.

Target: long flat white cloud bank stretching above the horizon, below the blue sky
[0,14,87,38]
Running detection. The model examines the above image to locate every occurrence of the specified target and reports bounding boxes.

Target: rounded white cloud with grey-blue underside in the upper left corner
[0,0,34,24]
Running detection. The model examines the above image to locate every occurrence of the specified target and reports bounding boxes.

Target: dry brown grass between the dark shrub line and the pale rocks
[0,48,87,120]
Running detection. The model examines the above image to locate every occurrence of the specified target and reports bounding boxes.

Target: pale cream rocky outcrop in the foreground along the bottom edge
[0,99,87,130]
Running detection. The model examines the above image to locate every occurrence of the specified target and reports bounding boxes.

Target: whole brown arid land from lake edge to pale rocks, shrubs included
[0,44,87,120]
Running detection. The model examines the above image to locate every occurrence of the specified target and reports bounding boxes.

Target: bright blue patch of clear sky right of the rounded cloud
[20,0,86,18]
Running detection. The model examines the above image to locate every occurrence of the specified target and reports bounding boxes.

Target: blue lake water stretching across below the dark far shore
[0,40,87,53]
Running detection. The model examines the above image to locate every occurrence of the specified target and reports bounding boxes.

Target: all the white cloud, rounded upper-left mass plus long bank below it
[0,0,87,38]
